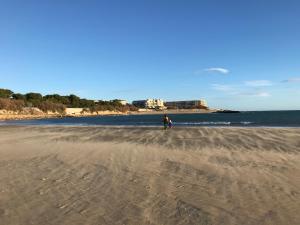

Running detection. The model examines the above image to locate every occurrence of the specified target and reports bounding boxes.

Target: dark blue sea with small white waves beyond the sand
[0,110,300,127]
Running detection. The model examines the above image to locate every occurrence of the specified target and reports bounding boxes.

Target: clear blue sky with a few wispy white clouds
[0,0,300,110]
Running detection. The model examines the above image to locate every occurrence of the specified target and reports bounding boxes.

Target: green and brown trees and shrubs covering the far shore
[0,89,137,113]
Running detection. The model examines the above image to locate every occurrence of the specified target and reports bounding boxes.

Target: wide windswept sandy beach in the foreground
[0,126,300,225]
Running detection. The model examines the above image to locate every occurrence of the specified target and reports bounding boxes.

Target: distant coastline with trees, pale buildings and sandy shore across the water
[0,88,239,121]
